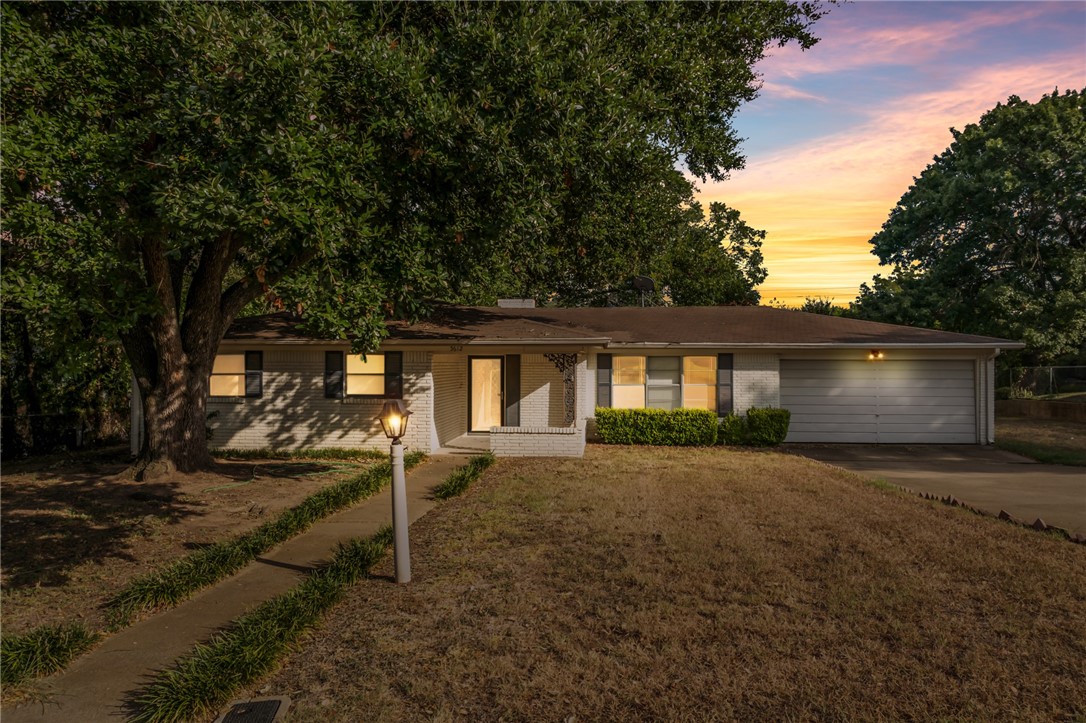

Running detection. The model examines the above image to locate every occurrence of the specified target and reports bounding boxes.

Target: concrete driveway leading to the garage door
[785,444,1086,534]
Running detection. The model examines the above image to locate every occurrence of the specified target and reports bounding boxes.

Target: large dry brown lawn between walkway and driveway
[251,446,1086,723]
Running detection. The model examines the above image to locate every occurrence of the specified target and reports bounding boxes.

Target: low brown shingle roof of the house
[226,306,1023,348]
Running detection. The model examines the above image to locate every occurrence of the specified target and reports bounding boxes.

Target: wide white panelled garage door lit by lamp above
[781,359,976,444]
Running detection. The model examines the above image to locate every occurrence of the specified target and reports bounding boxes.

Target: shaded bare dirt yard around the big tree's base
[0,448,373,633]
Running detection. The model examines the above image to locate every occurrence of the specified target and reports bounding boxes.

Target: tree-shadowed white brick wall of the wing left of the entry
[207,345,433,452]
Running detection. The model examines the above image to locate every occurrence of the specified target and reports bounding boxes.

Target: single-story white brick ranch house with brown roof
[155,300,1023,456]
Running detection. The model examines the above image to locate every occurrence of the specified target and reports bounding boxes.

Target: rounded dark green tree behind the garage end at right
[853,91,1086,364]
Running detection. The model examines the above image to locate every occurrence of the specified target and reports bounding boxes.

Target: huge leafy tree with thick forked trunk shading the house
[0,2,821,470]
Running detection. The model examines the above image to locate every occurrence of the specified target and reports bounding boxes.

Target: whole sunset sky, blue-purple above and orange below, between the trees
[700,0,1086,305]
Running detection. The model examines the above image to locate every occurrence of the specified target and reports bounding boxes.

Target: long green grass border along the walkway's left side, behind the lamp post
[106,452,425,629]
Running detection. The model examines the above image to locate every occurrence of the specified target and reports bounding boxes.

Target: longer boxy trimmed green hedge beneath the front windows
[596,407,717,446]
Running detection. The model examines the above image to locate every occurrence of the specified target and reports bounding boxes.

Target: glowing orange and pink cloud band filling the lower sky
[699,56,1086,304]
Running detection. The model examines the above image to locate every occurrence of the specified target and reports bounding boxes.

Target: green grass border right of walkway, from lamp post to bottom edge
[131,527,392,723]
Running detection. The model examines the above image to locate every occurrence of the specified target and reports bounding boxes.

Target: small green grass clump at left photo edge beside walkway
[0,623,101,686]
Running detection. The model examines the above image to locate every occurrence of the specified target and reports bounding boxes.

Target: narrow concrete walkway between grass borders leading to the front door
[2,456,467,723]
